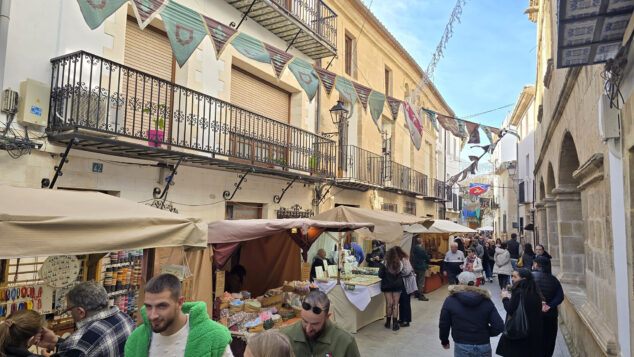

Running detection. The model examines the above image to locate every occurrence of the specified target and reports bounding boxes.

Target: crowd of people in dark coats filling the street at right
[439,234,564,357]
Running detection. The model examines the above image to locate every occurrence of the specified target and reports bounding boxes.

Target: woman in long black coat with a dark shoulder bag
[495,268,544,357]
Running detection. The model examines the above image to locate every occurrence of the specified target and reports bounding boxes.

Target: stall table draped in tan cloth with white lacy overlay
[316,281,385,333]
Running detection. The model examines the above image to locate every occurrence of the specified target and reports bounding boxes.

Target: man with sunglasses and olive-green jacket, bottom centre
[282,291,360,357]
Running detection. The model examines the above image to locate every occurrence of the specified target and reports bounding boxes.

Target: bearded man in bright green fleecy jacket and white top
[125,274,233,357]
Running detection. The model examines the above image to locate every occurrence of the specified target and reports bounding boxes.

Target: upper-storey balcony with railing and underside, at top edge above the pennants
[226,0,337,60]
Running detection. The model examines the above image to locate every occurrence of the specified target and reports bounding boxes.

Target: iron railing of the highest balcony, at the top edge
[273,0,337,49]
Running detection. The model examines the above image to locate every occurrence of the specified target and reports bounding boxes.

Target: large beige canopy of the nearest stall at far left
[0,185,207,258]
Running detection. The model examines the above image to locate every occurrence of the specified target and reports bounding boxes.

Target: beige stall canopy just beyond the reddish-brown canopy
[313,206,433,244]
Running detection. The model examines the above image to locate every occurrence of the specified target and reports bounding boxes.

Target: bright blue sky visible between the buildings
[363,0,537,172]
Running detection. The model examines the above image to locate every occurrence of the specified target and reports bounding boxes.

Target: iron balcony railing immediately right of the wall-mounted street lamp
[339,145,383,186]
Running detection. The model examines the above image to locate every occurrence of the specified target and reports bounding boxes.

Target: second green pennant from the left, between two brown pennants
[161,1,207,67]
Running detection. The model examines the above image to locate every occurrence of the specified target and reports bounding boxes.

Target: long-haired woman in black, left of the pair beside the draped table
[379,246,405,331]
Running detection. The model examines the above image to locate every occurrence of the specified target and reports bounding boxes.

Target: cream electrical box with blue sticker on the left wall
[18,78,51,127]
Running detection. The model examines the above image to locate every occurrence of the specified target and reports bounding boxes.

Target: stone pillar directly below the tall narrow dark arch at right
[553,185,586,286]
